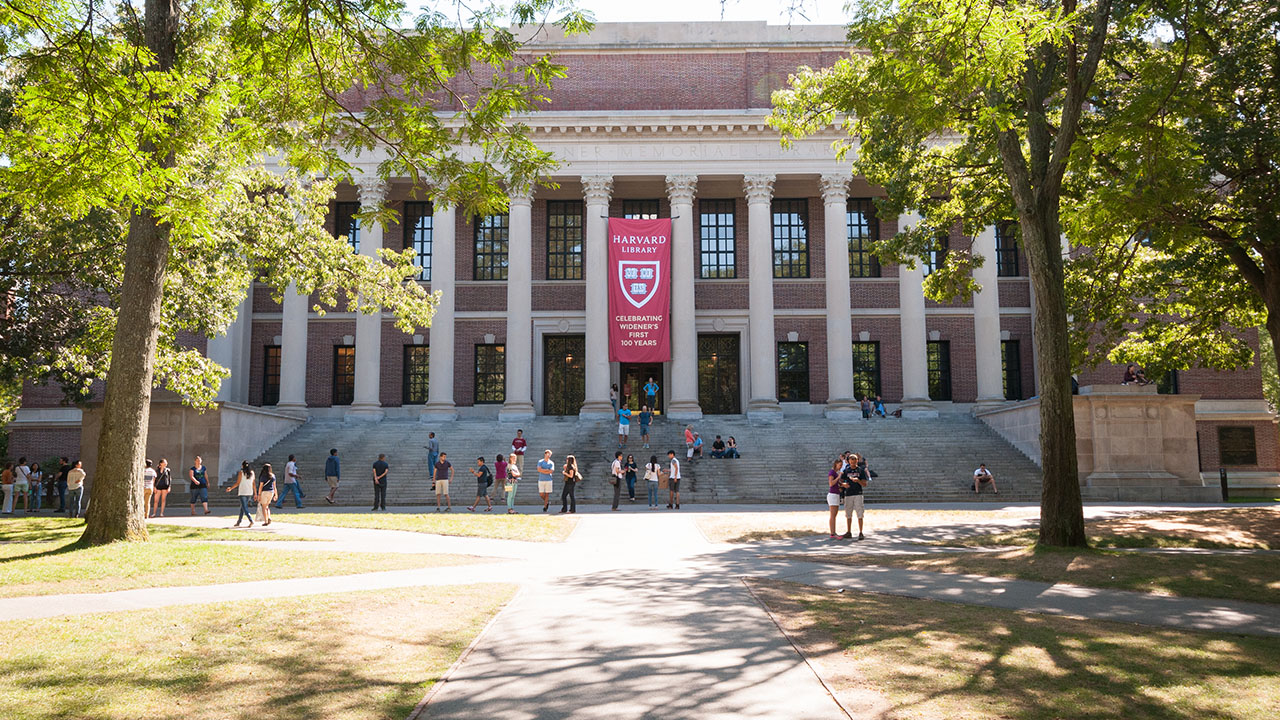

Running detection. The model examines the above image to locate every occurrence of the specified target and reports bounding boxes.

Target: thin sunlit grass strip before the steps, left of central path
[280,506,577,542]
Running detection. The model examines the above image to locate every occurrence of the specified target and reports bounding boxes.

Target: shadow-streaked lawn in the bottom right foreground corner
[751,582,1280,720]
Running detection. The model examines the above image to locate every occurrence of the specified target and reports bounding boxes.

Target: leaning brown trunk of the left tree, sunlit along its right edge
[81,0,178,544]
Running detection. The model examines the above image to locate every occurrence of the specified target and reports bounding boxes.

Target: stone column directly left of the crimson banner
[579,176,613,419]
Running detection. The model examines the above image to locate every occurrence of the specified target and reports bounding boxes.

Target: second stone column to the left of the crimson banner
[498,190,534,421]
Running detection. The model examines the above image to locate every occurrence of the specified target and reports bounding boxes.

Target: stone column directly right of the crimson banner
[667,176,703,420]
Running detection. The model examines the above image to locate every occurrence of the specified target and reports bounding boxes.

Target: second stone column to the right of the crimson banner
[742,174,782,423]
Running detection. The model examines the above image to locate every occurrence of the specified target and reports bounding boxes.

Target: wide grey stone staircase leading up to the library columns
[211,414,1041,507]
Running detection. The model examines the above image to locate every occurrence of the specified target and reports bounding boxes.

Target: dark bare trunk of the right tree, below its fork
[1023,211,1088,547]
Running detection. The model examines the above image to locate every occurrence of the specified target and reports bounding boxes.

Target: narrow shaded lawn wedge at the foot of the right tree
[785,547,1280,603]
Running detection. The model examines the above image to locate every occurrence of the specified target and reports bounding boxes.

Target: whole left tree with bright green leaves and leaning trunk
[0,0,586,543]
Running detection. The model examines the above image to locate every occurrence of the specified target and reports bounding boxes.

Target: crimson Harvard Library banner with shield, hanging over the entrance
[609,212,671,363]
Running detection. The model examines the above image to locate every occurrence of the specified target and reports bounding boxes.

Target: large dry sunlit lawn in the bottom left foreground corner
[0,584,515,720]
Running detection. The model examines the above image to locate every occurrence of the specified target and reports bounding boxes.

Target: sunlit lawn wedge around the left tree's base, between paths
[0,527,480,597]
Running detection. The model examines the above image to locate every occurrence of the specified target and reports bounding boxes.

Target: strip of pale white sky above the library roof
[577,0,847,24]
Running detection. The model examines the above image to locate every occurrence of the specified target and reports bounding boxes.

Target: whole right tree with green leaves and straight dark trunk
[771,0,1133,546]
